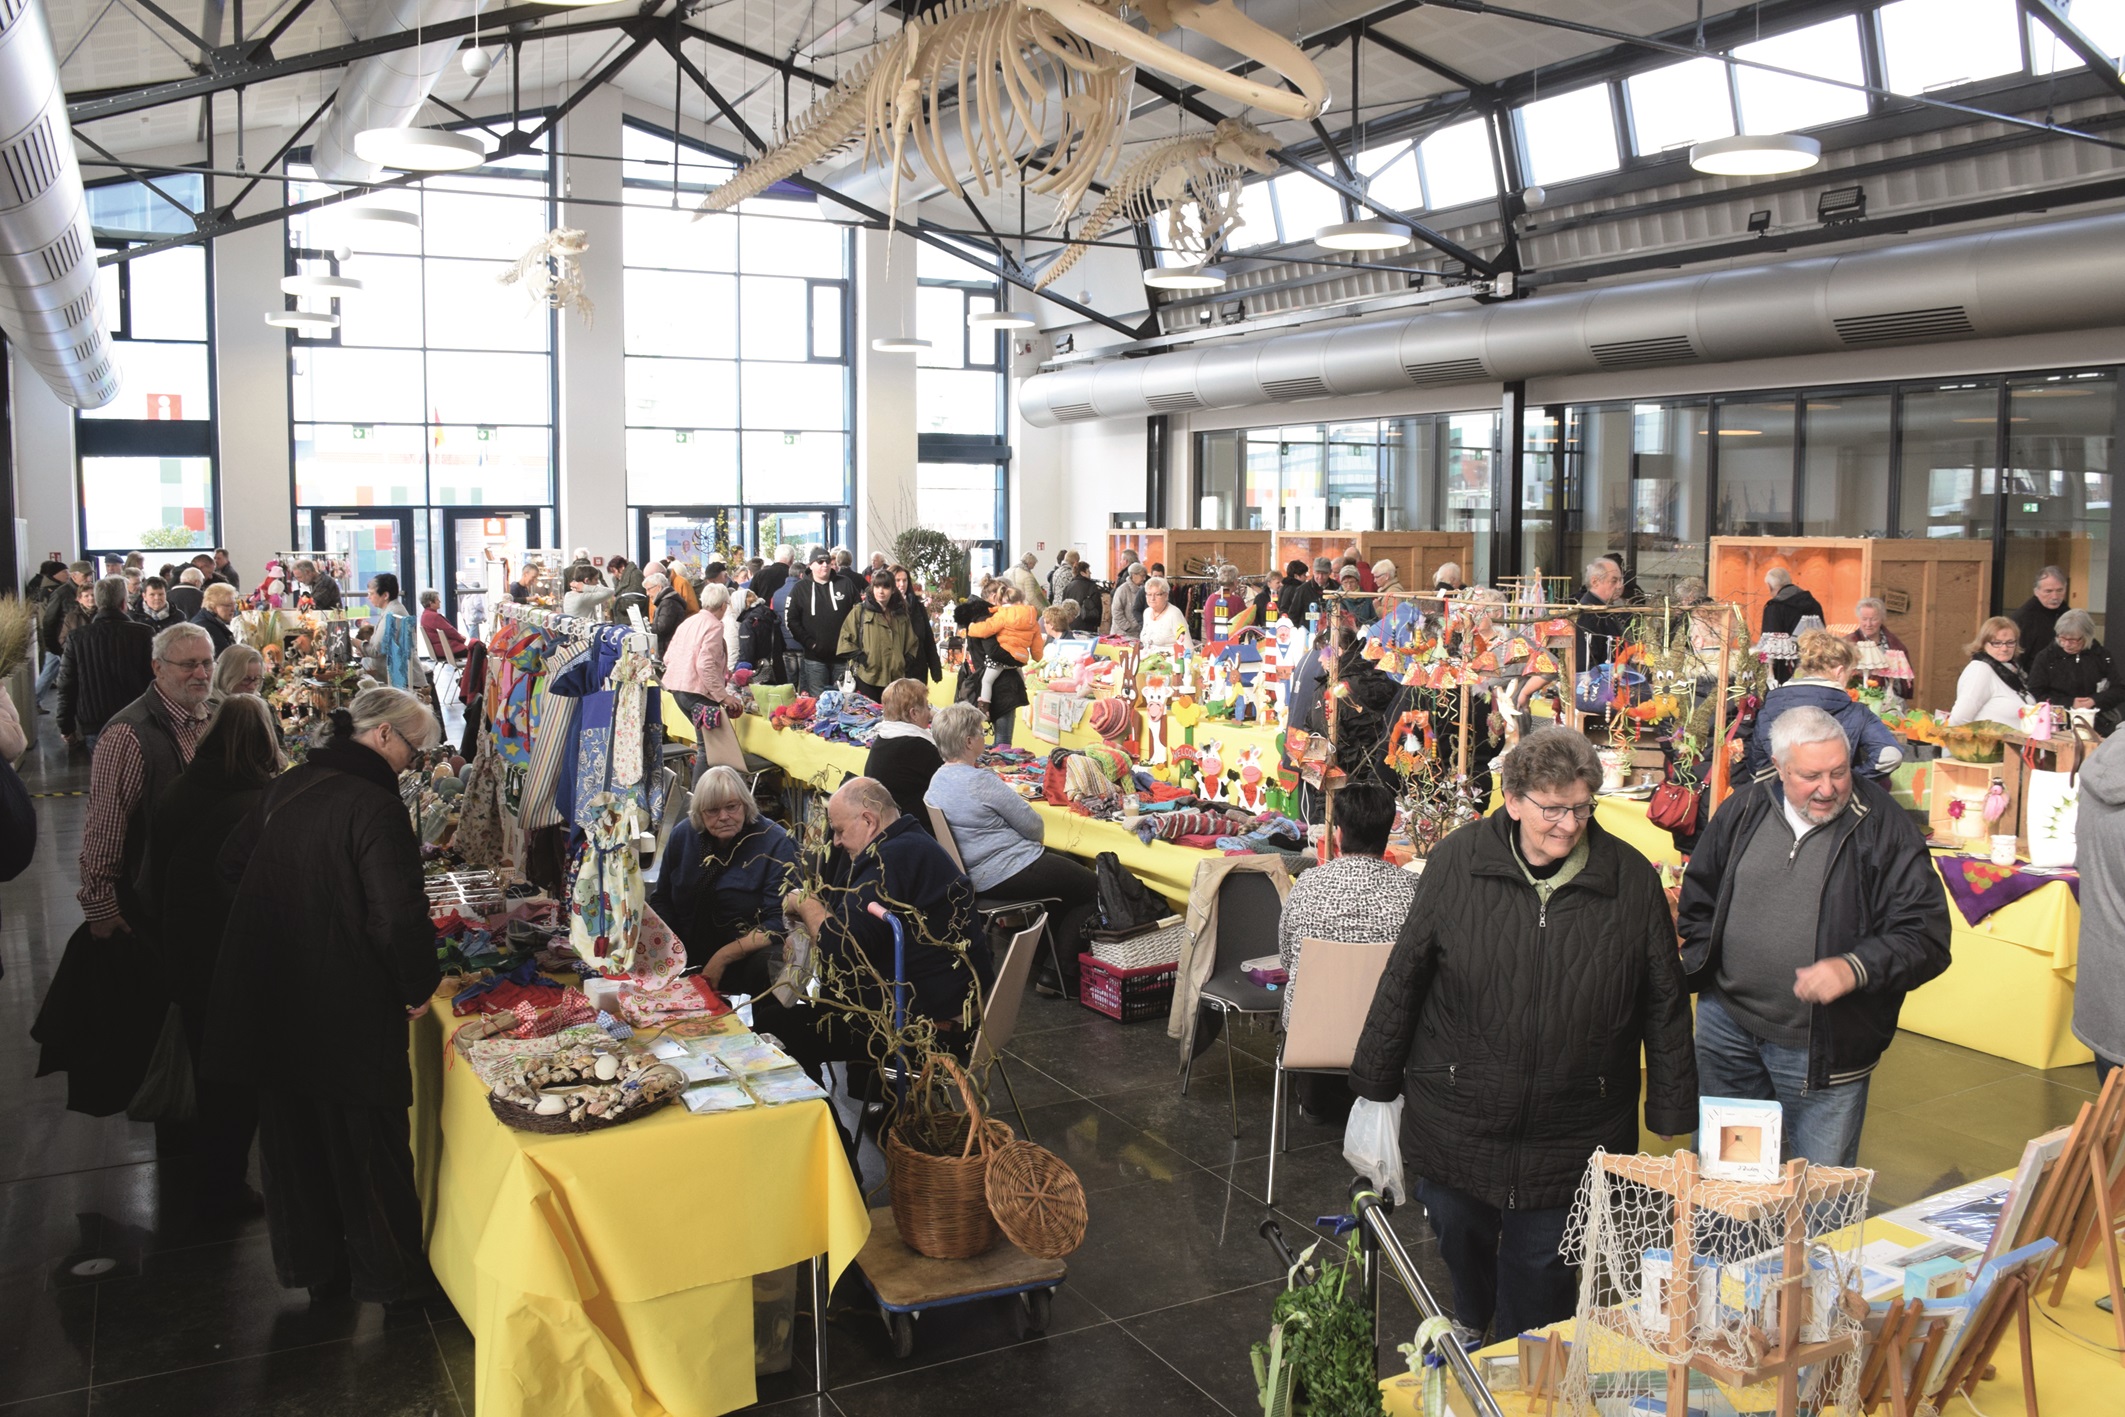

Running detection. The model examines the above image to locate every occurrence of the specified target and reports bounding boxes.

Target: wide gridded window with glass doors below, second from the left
[287,129,556,595]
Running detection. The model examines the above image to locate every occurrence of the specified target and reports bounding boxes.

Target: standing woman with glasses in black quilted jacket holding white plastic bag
[1349,727,1698,1334]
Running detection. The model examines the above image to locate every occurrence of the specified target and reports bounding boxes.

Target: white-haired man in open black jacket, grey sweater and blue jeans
[1677,707,1949,1166]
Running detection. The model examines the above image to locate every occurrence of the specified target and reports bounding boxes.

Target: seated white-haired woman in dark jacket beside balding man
[650,765,797,994]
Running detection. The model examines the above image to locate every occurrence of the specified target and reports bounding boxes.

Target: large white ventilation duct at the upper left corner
[0,0,119,408]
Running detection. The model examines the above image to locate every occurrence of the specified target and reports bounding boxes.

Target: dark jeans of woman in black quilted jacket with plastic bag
[1417,1177,1579,1341]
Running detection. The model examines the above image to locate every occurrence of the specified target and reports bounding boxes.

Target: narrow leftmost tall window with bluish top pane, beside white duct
[74,174,221,567]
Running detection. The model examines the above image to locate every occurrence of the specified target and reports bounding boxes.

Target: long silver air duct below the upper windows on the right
[1018,212,2125,427]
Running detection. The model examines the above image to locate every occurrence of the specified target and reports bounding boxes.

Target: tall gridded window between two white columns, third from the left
[621,121,854,559]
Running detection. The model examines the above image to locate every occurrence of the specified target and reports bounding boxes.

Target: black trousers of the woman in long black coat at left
[259,1088,436,1302]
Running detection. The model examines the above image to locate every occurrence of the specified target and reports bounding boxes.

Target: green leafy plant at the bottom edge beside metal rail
[1252,1232,1386,1417]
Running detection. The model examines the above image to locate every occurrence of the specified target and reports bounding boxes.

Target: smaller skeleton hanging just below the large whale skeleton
[1033,119,1277,289]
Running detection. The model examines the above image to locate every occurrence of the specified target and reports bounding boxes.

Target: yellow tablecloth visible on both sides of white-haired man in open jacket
[1594,797,2095,1069]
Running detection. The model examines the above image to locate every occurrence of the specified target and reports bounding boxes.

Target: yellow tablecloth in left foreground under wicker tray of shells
[412,1001,871,1417]
